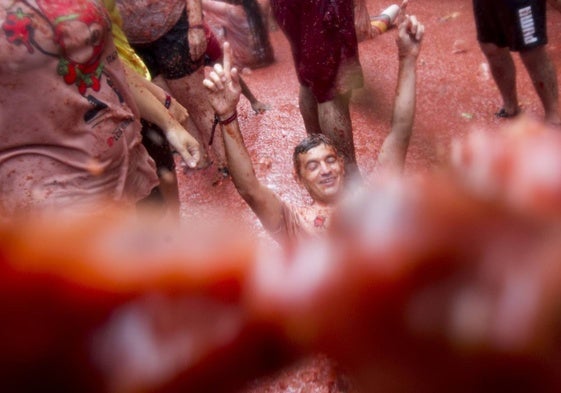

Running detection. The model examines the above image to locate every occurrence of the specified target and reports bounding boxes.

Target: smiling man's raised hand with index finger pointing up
[203,42,242,116]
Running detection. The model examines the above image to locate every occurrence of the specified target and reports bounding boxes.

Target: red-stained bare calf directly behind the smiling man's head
[318,93,358,175]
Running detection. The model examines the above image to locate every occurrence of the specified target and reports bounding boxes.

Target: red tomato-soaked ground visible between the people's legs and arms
[178,0,561,234]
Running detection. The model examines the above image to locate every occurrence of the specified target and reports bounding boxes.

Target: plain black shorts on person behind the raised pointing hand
[132,11,204,79]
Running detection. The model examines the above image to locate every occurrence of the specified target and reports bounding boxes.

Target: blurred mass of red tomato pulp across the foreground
[5,119,561,392]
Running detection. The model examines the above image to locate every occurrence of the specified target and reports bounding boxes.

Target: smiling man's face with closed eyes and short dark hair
[298,143,345,204]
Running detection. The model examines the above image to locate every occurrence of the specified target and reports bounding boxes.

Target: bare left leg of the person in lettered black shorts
[480,43,518,114]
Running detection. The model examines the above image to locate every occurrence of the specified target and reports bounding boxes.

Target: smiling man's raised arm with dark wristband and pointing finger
[203,42,283,231]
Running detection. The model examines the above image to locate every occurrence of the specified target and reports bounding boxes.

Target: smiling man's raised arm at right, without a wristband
[378,16,424,171]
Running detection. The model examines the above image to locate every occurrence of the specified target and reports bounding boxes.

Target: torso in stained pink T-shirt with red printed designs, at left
[0,0,156,212]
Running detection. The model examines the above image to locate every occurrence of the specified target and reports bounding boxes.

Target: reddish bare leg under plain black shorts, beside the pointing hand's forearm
[166,67,226,168]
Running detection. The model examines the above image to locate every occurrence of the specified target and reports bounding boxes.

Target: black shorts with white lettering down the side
[473,0,547,51]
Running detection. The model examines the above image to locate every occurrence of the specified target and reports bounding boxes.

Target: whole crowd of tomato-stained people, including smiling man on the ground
[0,0,561,390]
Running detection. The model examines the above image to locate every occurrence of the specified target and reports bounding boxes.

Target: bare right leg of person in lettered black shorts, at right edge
[520,46,561,125]
